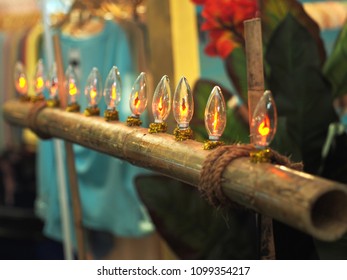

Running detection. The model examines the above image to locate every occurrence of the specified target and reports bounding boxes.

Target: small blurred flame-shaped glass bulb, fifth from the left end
[84,67,102,107]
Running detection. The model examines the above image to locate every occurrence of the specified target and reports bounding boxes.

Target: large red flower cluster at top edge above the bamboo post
[192,0,258,58]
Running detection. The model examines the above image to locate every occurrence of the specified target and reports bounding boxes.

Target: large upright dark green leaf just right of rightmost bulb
[266,14,336,173]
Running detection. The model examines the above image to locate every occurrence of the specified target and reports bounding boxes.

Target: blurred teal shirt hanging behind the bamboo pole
[36,21,153,245]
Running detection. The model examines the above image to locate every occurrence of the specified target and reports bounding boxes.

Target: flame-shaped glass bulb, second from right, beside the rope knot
[205,86,227,141]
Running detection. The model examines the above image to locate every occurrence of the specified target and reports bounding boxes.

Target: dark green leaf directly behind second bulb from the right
[190,79,249,143]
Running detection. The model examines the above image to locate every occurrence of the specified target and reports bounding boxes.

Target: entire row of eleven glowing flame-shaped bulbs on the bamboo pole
[14,59,276,148]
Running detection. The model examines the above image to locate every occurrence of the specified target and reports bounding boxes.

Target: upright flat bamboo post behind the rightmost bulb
[244,18,275,259]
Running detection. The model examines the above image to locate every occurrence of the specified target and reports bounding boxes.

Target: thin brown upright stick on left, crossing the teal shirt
[53,34,87,260]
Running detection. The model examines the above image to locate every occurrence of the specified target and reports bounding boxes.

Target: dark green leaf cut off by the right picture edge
[323,23,347,97]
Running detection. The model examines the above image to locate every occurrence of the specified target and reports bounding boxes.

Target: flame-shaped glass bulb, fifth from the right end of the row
[129,72,147,116]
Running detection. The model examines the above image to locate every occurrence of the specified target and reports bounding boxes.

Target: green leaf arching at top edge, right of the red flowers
[260,0,326,64]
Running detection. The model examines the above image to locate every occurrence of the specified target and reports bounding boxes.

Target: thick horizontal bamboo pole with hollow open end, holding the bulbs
[3,100,347,241]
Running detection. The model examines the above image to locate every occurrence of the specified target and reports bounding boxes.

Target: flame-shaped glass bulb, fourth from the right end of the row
[152,75,171,123]
